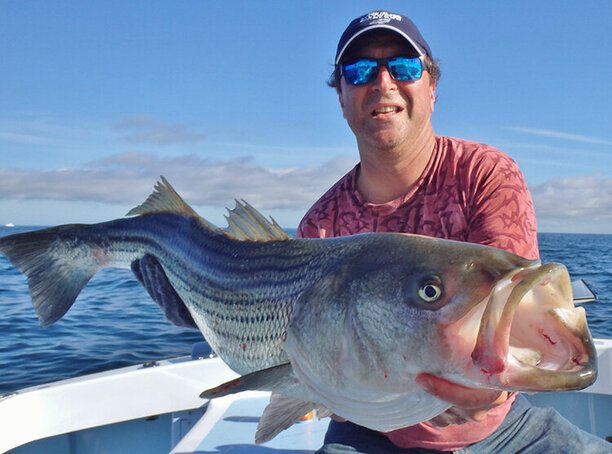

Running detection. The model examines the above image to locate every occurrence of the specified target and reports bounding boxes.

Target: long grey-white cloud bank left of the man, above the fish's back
[0,152,355,209]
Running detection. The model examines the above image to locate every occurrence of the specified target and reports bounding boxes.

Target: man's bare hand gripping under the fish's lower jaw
[415,374,508,427]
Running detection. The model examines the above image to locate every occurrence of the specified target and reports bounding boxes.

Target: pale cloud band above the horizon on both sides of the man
[0,152,612,233]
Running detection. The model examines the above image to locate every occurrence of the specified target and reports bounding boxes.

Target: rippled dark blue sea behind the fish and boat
[0,227,612,394]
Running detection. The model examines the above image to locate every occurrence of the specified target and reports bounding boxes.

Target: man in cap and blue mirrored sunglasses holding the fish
[298,11,610,453]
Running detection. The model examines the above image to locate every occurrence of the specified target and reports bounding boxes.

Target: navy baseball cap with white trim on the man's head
[336,11,433,64]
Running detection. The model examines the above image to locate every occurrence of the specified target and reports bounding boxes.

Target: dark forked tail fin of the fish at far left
[0,224,102,327]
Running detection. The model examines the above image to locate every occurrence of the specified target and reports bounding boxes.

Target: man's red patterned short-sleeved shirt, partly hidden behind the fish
[297,136,539,451]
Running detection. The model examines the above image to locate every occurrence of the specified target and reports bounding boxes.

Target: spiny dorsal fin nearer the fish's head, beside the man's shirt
[225,200,291,241]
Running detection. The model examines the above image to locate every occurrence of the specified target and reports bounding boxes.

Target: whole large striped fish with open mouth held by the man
[0,177,596,442]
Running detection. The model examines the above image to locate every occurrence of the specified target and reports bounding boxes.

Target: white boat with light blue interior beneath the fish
[0,282,612,454]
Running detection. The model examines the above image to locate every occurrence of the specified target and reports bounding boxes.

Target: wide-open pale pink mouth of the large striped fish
[471,263,597,391]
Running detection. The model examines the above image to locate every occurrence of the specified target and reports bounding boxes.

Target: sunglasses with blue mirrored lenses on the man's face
[340,56,427,85]
